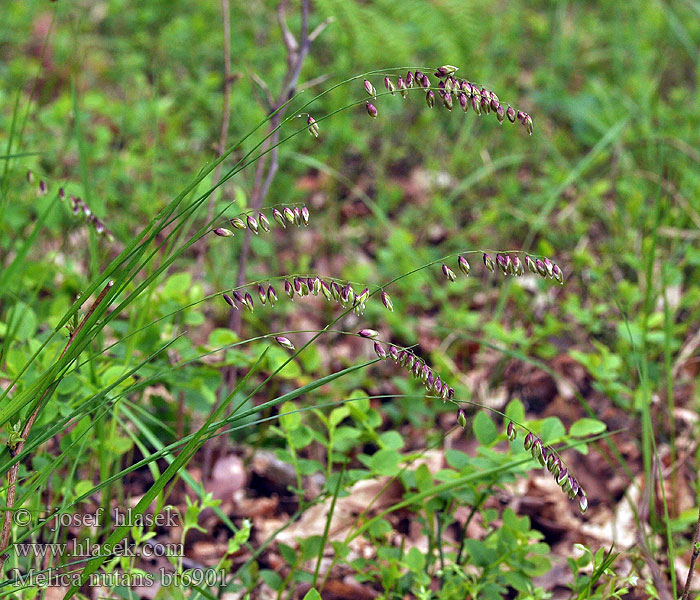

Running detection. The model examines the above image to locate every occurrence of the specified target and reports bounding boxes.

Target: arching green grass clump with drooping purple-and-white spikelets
[0,57,600,597]
